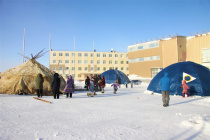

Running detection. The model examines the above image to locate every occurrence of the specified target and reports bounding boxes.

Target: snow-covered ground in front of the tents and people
[0,84,210,140]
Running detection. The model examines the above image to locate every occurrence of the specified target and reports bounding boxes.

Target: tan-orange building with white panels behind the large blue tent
[128,33,210,77]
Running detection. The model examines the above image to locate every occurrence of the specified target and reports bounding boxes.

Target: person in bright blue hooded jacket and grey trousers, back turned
[160,72,171,107]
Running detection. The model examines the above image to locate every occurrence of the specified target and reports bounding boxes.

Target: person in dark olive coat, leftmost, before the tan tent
[35,73,44,98]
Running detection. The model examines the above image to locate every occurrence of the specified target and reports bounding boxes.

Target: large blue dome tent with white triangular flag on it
[147,61,210,96]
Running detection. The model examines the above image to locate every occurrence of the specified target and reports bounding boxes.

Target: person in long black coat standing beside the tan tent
[51,73,60,99]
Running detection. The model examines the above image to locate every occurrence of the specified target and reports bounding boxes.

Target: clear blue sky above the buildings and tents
[0,0,210,72]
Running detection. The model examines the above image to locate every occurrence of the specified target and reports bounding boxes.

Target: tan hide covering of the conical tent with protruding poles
[0,59,66,95]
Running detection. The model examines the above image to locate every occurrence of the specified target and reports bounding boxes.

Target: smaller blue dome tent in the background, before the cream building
[101,70,130,84]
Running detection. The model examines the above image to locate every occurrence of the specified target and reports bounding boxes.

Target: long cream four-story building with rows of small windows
[50,50,129,80]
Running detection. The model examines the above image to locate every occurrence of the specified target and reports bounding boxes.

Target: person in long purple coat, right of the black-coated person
[64,75,74,98]
